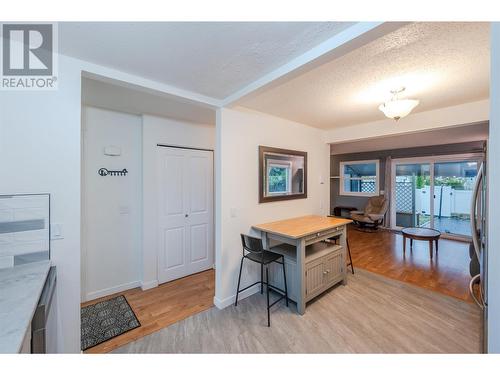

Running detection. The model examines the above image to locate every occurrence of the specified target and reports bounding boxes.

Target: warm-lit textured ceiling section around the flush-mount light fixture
[238,22,490,129]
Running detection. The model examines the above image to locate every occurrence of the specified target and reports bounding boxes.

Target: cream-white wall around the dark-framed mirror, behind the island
[214,108,330,308]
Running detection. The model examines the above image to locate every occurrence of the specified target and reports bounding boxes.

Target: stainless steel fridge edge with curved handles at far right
[469,162,488,351]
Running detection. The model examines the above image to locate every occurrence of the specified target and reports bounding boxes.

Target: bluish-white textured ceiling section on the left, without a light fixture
[59,22,353,99]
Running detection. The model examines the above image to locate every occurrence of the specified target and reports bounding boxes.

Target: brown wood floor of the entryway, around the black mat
[82,269,215,353]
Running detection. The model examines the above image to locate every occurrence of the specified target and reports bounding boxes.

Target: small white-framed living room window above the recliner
[340,160,379,196]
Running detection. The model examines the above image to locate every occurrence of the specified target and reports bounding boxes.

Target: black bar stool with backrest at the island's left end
[234,234,288,327]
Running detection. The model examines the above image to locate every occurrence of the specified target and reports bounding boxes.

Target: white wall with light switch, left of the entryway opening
[0,56,81,353]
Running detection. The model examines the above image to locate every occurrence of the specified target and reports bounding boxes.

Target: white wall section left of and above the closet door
[142,115,215,289]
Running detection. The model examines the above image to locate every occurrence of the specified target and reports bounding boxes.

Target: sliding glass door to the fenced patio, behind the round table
[391,155,482,237]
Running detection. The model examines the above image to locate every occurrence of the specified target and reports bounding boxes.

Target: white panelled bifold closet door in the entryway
[158,147,214,283]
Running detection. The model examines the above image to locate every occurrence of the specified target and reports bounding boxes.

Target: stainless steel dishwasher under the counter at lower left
[31,267,57,354]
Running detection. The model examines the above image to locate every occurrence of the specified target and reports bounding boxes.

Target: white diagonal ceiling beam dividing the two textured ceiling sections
[222,22,407,107]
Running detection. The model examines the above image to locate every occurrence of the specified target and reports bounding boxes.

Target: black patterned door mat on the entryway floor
[81,296,141,350]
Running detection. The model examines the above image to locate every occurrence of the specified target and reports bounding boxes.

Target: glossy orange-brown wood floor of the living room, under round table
[348,227,472,302]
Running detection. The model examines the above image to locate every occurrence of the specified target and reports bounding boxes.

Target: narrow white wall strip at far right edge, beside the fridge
[487,22,500,353]
